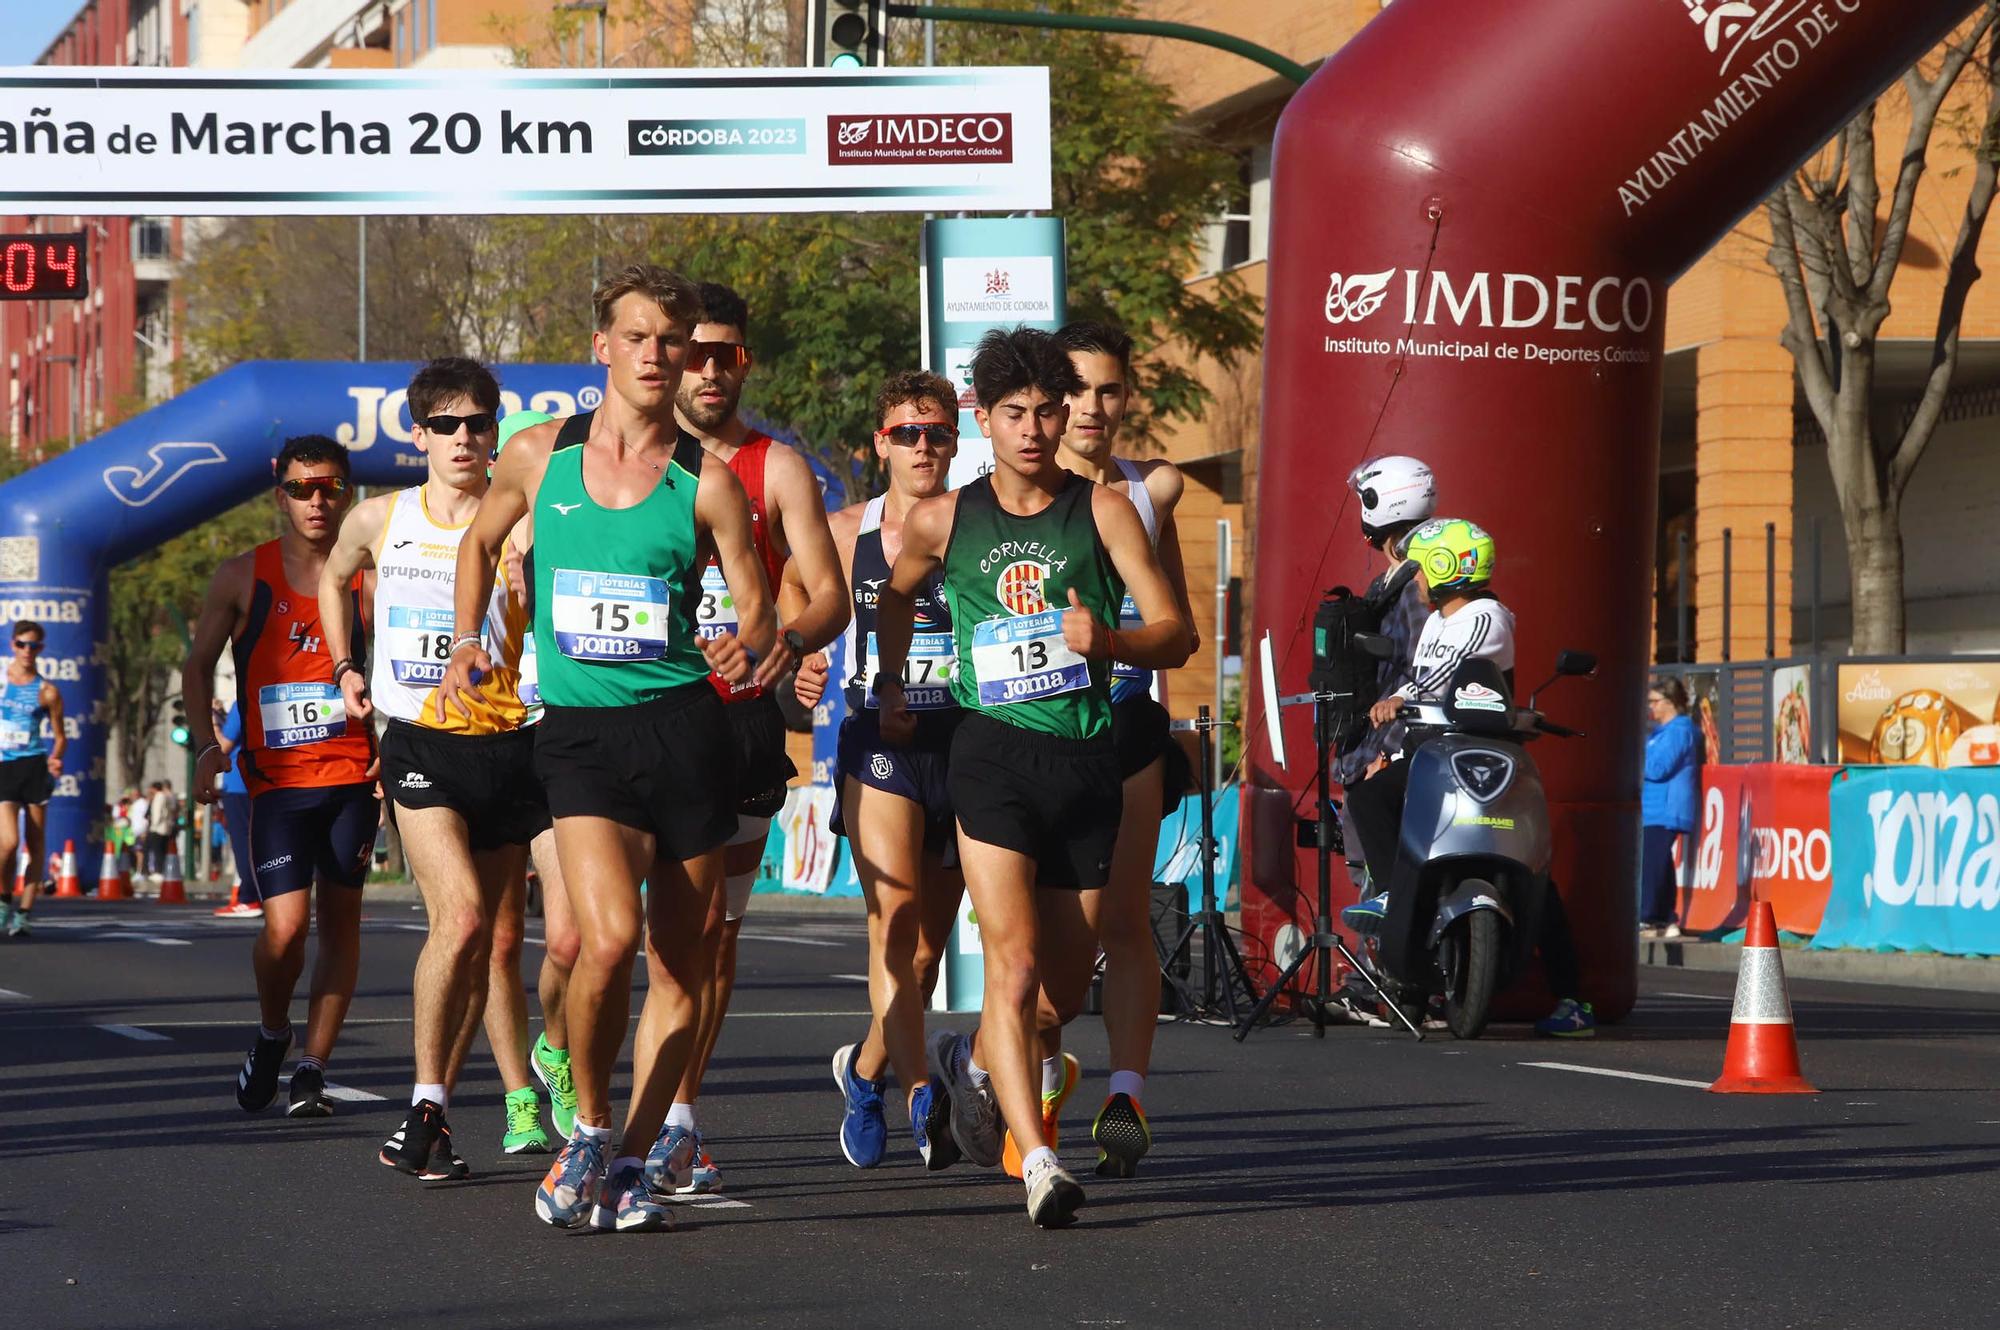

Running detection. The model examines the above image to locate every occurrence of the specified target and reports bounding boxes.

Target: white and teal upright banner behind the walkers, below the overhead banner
[922,215,1068,488]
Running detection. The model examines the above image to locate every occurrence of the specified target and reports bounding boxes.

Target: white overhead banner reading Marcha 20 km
[0,66,1050,216]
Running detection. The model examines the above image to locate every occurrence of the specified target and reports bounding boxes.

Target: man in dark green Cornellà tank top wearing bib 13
[874,328,1190,1228]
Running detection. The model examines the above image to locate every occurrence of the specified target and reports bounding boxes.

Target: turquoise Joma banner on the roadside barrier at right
[1812,768,2000,956]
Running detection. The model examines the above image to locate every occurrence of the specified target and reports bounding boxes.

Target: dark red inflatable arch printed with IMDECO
[1244,0,1970,1020]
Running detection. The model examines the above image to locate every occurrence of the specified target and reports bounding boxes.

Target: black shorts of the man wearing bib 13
[946,712,1124,890]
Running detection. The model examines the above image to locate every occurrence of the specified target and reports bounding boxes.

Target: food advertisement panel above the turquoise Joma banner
[1834,656,2000,768]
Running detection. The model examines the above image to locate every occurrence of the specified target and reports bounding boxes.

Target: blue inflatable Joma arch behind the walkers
[0,360,846,862]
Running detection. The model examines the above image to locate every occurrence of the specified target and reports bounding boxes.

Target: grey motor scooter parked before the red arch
[1368,638,1598,1040]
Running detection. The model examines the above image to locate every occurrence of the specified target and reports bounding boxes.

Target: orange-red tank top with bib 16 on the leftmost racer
[234,540,374,794]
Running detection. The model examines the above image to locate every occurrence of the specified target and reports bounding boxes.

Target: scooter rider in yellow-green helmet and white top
[1340,518,1596,1038]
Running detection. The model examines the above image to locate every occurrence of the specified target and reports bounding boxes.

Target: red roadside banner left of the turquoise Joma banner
[1680,762,1838,934]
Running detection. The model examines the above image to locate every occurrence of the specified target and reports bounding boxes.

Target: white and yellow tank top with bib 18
[368,486,528,734]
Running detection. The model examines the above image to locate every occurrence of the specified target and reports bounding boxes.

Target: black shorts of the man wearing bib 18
[382,720,548,850]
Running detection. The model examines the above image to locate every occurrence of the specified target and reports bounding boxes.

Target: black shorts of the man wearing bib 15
[534,678,736,860]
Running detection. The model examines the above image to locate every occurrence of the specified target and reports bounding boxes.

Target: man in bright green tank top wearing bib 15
[438,266,776,1230]
